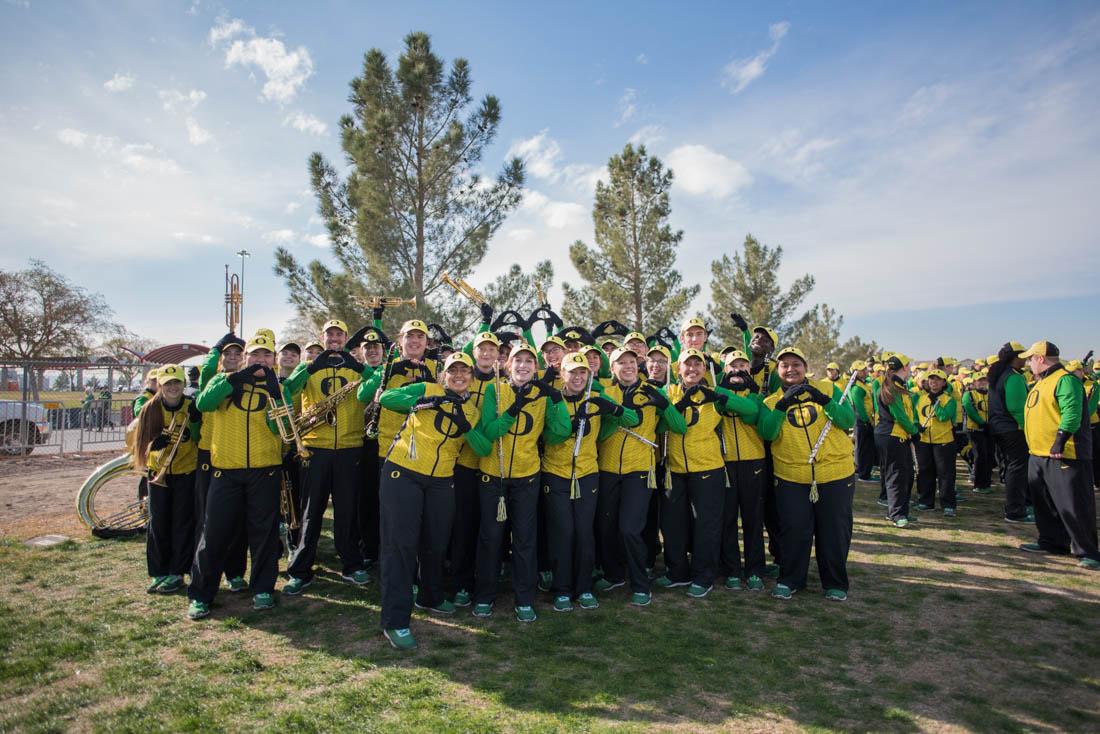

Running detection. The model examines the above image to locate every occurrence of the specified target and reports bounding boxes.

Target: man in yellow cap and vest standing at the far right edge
[1020,341,1100,571]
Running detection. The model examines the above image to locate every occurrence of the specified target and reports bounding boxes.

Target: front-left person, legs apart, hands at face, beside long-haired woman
[187,336,283,620]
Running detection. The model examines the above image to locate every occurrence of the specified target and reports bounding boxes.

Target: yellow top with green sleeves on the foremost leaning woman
[380,382,490,476]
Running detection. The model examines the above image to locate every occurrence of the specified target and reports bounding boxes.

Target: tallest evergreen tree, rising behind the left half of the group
[275,33,524,332]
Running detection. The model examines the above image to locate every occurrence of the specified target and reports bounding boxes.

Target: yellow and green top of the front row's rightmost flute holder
[756,380,856,484]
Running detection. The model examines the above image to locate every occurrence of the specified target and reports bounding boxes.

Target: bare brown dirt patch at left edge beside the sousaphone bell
[0,451,119,540]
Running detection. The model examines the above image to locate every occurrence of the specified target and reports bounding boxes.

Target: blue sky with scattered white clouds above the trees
[0,0,1100,355]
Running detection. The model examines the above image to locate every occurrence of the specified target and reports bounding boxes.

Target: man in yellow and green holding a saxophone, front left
[283,319,374,596]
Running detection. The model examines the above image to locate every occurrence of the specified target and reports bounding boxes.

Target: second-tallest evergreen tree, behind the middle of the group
[562,143,700,333]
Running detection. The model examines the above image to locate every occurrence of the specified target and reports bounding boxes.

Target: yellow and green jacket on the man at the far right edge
[1024,364,1089,459]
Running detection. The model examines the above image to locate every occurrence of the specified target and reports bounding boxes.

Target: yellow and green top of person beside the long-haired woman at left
[195,373,283,469]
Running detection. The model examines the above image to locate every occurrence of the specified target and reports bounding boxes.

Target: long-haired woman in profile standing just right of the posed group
[875,354,919,527]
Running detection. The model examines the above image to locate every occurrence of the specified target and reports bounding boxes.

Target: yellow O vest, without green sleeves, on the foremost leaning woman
[382,382,481,476]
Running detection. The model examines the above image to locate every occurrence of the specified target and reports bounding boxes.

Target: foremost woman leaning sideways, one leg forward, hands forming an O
[376,352,488,650]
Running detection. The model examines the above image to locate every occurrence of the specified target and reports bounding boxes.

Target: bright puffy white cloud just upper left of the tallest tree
[207,18,320,103]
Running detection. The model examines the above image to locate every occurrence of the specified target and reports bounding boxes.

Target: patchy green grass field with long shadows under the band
[0,484,1100,732]
